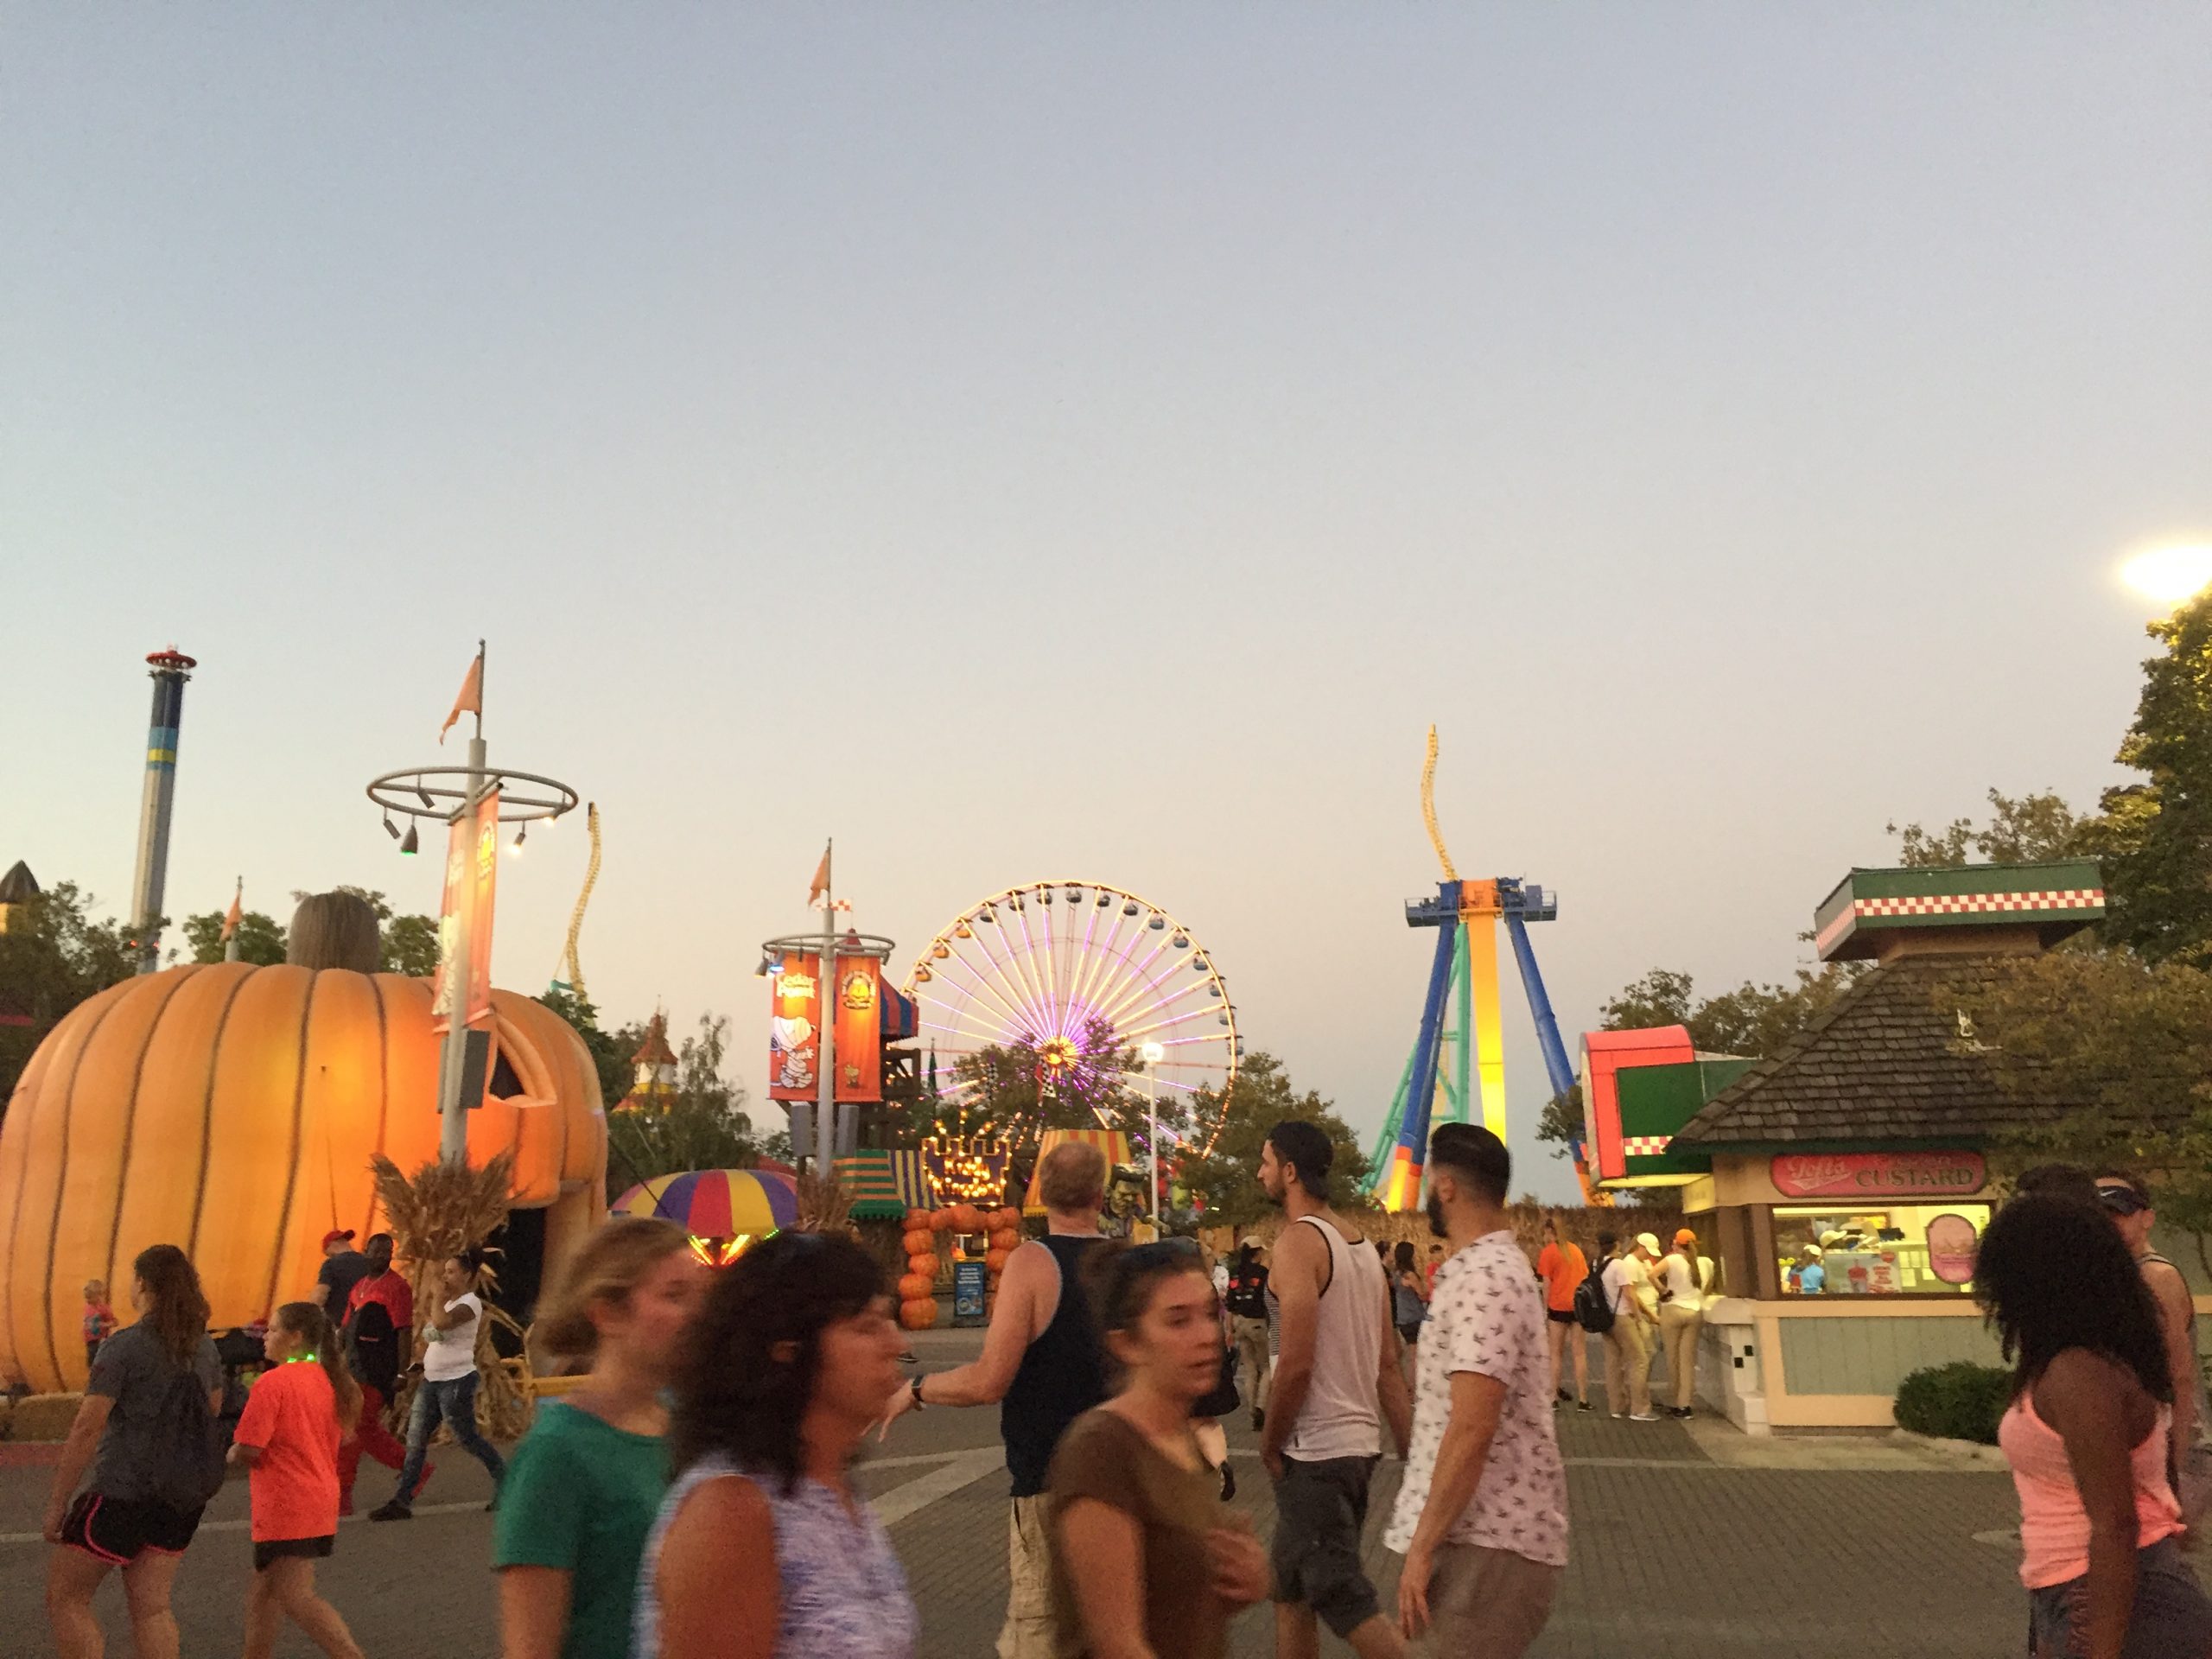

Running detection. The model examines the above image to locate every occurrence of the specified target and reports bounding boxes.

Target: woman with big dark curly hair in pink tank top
[1975,1192,2212,1659]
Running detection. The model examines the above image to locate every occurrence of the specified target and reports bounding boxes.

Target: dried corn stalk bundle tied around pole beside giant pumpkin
[370,1153,533,1440]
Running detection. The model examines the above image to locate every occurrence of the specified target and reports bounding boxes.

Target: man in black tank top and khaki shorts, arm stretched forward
[885,1141,1106,1659]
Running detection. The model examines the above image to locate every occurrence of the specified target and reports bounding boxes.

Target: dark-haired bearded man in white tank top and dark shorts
[1259,1119,1414,1659]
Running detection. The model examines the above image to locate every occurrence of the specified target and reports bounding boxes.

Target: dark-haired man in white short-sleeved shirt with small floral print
[1382,1123,1566,1659]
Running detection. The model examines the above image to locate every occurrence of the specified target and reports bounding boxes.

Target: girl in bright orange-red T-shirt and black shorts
[230,1303,360,1659]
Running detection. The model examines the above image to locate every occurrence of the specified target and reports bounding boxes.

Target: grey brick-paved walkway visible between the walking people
[0,1332,2024,1659]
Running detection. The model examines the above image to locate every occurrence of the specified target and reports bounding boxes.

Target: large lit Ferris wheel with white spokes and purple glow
[907,880,1243,1141]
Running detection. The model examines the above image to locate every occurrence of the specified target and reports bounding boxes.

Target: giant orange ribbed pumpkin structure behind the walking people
[0,963,606,1391]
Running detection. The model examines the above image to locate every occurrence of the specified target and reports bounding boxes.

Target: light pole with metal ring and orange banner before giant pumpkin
[370,677,577,1164]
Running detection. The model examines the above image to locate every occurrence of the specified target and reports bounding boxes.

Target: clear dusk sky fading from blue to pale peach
[0,3,2212,1197]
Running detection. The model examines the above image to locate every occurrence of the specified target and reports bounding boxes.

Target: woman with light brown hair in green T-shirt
[491,1217,706,1659]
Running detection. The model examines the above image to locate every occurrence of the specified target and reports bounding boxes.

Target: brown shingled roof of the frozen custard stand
[1675,956,2077,1153]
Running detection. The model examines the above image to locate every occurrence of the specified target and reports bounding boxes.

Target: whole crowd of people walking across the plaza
[44,1119,2212,1659]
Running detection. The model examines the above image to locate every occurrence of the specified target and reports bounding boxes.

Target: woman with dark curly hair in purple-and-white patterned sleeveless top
[635,1232,918,1659]
